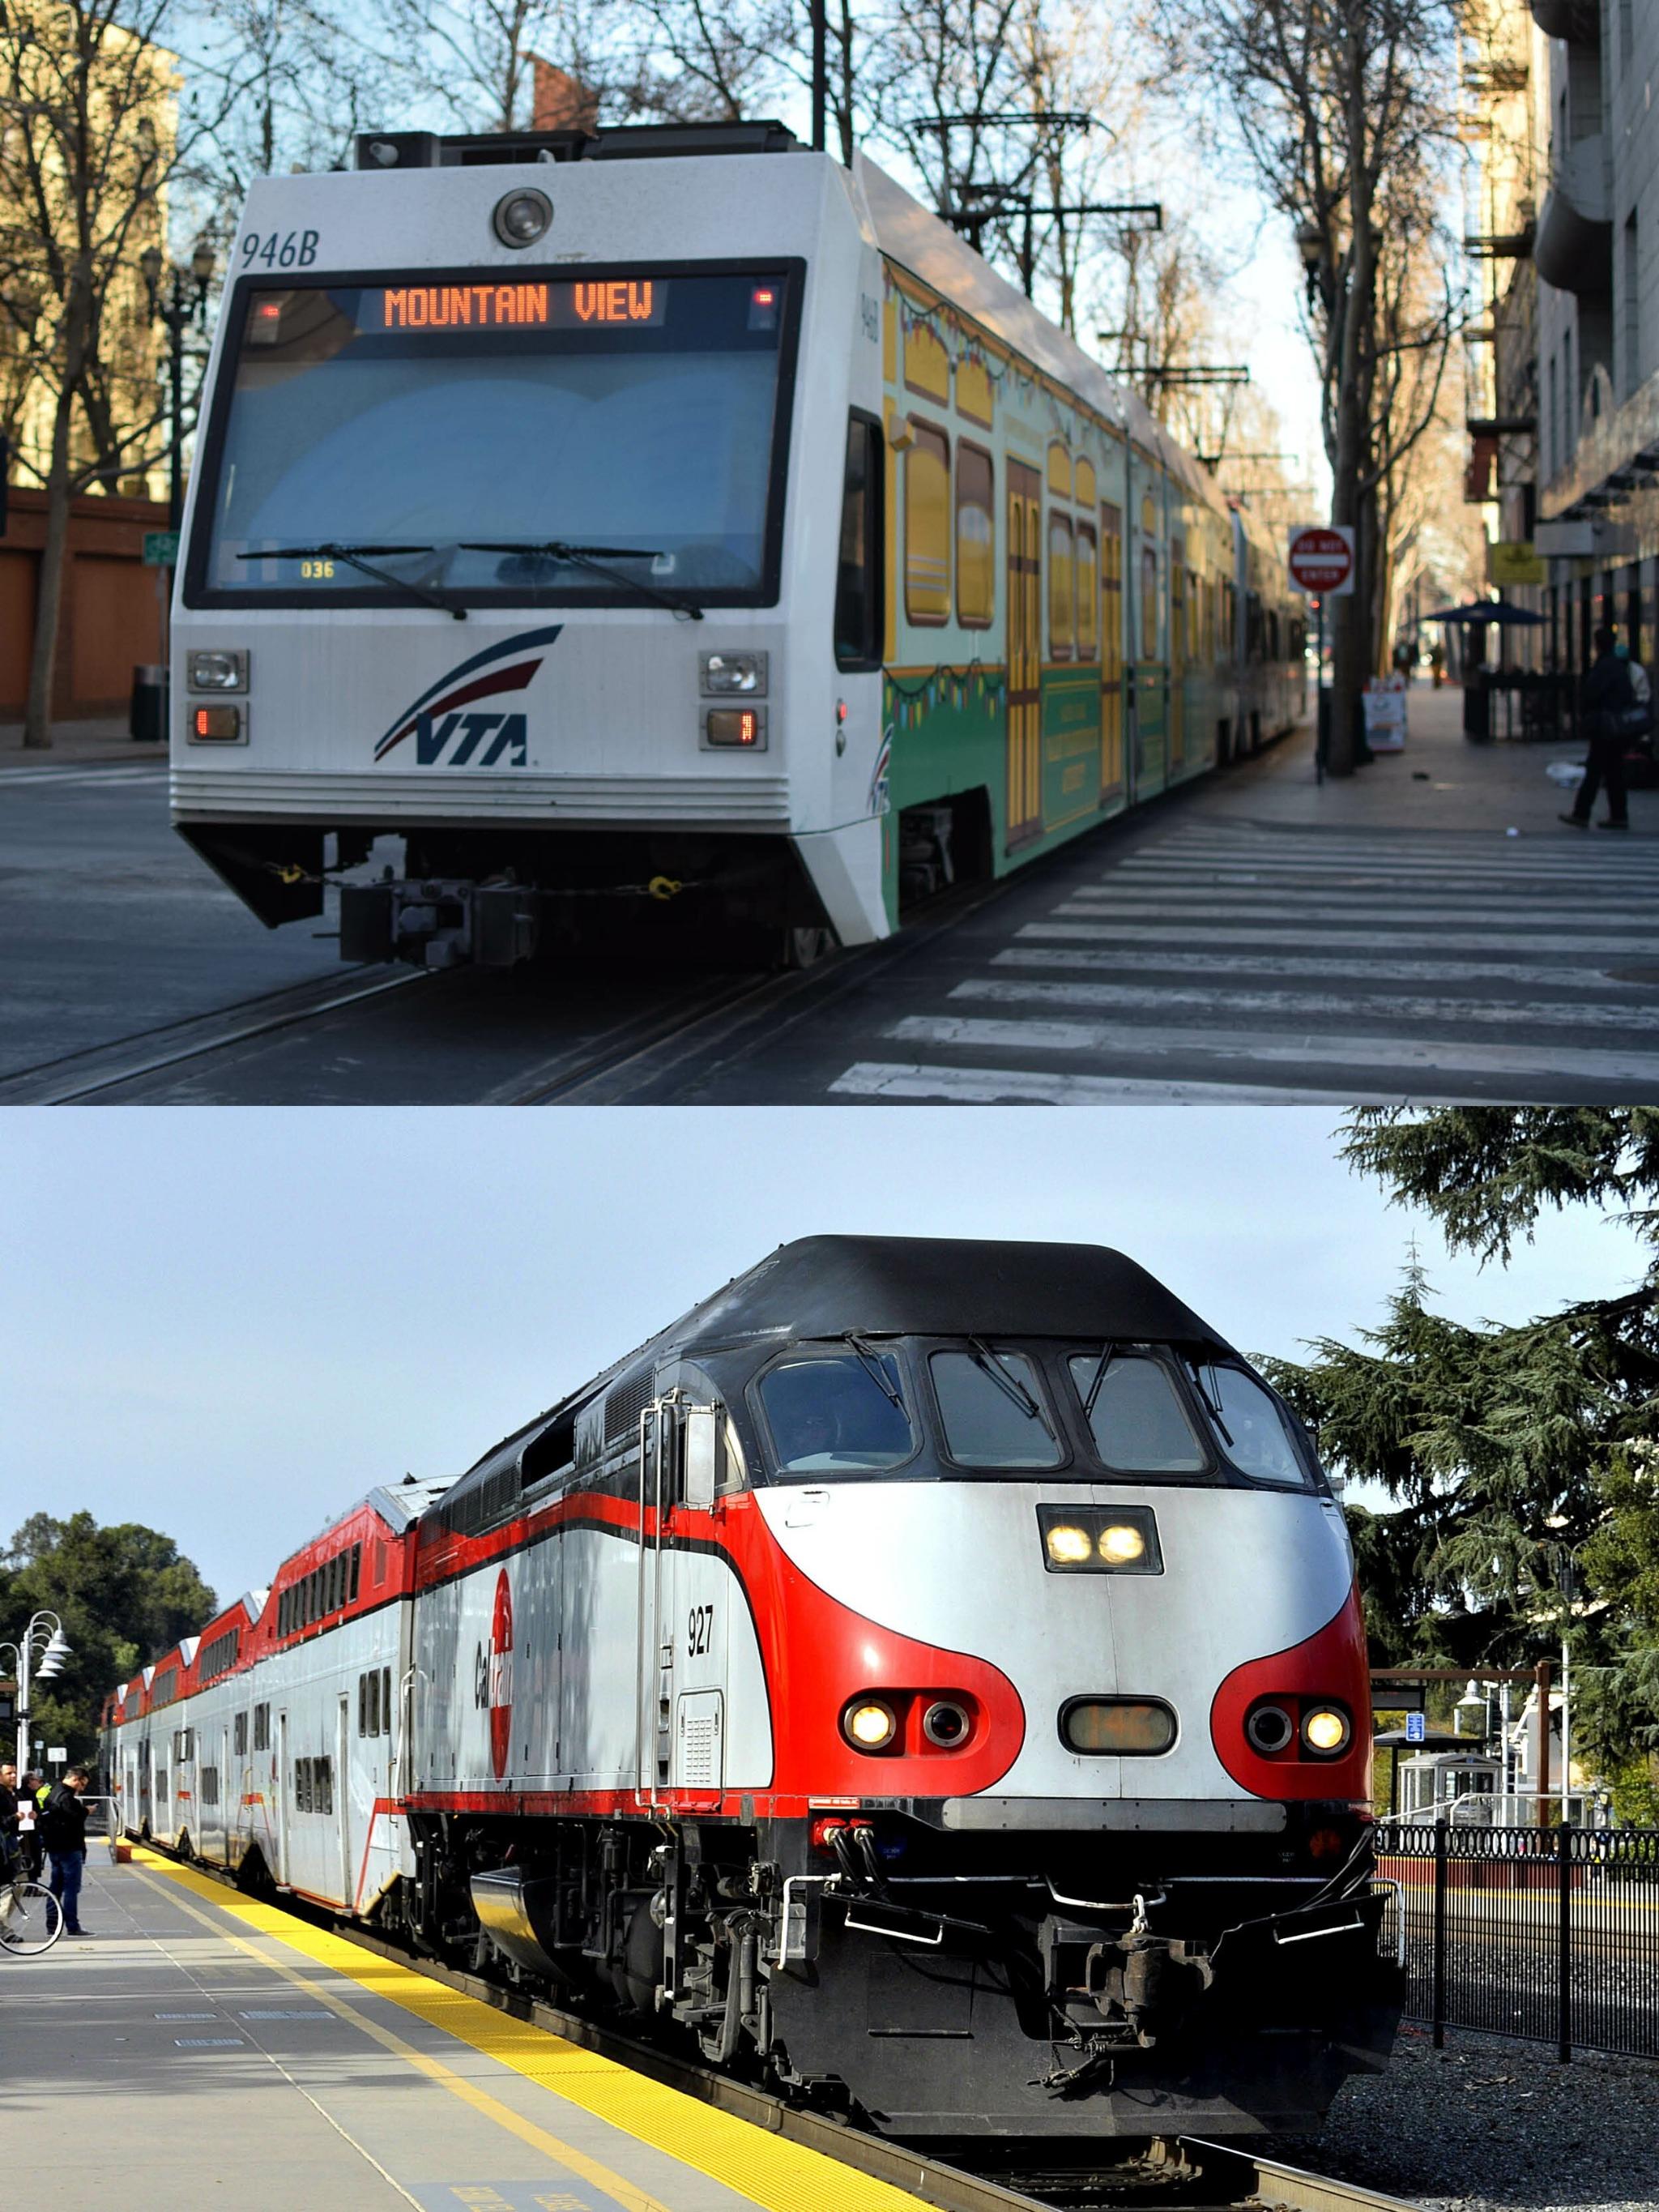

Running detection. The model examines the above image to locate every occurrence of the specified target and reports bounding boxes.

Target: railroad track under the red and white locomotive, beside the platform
[126,1843,1420,2212]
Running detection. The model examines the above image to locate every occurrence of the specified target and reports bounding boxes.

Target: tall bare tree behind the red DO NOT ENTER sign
[1154,0,1458,775]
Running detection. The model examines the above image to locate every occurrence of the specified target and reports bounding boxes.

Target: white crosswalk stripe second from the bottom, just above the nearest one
[885,1013,1659,1095]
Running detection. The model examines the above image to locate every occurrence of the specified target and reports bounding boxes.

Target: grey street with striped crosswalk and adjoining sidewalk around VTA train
[0,692,1659,1106]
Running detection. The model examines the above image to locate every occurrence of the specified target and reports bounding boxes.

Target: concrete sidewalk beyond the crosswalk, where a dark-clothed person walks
[1230,684,1659,845]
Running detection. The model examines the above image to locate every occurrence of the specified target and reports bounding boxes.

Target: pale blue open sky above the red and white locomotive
[0,1106,1641,1628]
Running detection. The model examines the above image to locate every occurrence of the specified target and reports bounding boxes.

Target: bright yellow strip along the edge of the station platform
[133,1849,929,2212]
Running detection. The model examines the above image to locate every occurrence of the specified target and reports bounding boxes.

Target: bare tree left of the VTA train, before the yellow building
[0,0,234,748]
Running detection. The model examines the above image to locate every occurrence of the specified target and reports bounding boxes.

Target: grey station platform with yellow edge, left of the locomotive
[13,1851,942,2212]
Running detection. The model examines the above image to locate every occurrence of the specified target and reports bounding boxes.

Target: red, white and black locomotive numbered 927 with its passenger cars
[104,1236,1401,2154]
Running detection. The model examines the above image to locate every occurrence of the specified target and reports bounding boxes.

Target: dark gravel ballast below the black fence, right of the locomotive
[1252,2024,1659,2212]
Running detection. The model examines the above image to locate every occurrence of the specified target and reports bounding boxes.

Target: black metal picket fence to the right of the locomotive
[1375,1821,1659,2060]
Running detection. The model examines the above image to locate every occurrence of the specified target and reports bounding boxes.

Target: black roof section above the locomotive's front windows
[659,1236,1228,1349]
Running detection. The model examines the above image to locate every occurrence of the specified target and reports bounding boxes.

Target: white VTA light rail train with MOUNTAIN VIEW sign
[170,124,1305,967]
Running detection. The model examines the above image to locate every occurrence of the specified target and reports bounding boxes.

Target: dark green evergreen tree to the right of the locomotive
[1272,1106,1659,1812]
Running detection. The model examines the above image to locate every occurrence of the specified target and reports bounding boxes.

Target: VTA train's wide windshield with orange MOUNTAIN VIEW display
[193,270,790,604]
